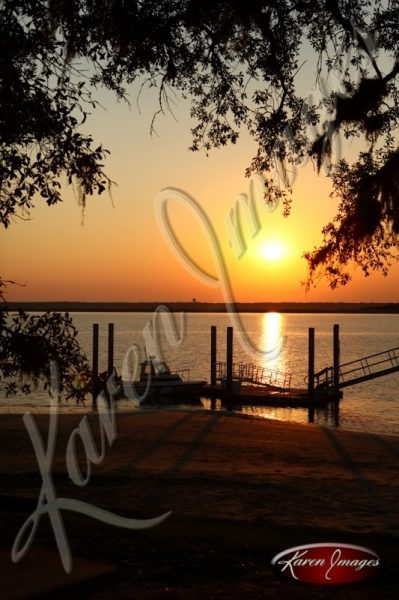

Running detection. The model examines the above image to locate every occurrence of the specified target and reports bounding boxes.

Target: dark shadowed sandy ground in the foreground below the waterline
[0,410,399,600]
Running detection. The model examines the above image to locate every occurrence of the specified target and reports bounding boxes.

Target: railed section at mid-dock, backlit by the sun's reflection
[216,362,292,392]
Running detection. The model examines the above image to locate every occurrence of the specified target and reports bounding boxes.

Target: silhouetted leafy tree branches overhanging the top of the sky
[0,0,399,287]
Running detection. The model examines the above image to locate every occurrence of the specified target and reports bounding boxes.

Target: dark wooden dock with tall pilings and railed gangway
[92,323,399,410]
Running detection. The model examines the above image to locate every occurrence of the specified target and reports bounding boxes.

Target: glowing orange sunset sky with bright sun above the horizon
[0,79,399,302]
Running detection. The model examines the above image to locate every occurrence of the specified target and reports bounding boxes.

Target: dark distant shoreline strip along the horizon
[2,301,399,314]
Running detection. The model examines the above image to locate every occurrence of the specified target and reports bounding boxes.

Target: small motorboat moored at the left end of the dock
[122,356,207,401]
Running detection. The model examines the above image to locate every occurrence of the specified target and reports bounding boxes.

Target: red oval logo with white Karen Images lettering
[272,542,382,585]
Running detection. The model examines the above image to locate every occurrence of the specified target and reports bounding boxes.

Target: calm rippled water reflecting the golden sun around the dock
[1,313,399,435]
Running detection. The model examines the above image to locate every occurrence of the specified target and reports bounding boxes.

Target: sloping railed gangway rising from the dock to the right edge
[314,346,399,390]
